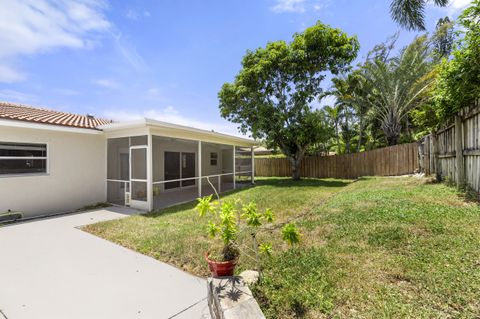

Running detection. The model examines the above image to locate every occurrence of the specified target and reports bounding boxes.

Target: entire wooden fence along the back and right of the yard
[255,102,480,192]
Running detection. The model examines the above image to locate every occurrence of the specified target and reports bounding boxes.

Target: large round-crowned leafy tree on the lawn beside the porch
[218,22,359,179]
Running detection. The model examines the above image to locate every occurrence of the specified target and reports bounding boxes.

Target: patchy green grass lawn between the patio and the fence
[85,177,480,318]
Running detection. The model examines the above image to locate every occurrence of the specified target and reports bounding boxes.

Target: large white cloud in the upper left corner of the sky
[0,0,111,82]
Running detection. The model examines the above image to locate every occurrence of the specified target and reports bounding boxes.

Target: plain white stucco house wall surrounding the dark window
[0,126,106,217]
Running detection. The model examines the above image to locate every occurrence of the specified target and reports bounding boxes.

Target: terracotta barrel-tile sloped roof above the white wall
[0,102,112,129]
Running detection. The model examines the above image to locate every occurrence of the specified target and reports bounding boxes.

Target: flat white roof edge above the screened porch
[98,118,257,146]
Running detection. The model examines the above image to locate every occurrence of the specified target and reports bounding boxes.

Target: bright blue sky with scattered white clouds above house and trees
[0,0,471,135]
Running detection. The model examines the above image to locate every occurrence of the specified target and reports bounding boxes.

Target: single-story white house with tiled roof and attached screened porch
[0,102,255,217]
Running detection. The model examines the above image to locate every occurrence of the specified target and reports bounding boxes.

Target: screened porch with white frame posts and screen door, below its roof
[102,122,254,211]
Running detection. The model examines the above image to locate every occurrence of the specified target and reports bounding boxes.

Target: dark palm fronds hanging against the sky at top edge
[390,0,449,31]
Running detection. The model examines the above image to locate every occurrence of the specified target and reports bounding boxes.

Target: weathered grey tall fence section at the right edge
[420,103,480,192]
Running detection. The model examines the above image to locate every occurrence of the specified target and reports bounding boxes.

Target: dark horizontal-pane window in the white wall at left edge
[0,142,47,175]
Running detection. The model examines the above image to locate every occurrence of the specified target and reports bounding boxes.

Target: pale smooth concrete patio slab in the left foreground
[0,208,210,319]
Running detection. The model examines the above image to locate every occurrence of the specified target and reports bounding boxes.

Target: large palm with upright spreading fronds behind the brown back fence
[364,36,433,145]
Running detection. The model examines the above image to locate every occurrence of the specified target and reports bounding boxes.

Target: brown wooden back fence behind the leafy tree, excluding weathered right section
[255,143,419,178]
